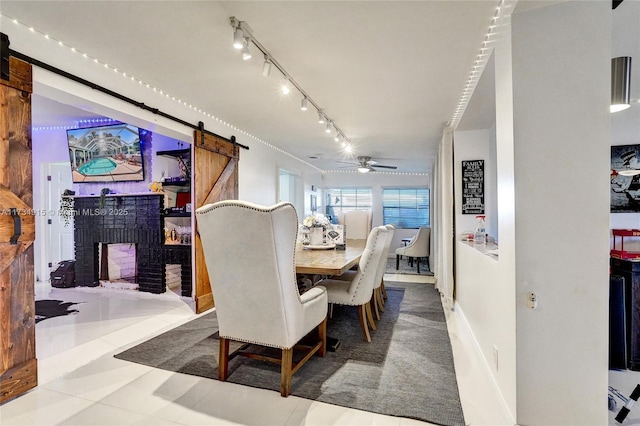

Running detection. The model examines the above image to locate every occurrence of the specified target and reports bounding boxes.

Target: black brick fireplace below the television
[74,193,166,294]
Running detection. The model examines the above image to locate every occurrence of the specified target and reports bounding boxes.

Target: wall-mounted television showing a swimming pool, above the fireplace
[67,123,144,183]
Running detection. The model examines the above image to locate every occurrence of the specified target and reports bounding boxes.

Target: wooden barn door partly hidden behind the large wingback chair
[193,130,239,313]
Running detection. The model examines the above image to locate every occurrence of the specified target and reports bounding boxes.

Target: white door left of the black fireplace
[44,163,75,274]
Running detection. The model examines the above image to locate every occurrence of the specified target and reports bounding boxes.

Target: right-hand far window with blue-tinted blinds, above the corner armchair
[382,188,429,229]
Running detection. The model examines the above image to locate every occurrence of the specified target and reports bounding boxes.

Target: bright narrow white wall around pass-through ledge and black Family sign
[454,9,518,416]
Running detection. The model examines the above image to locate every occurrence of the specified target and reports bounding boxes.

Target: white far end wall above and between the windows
[318,172,434,251]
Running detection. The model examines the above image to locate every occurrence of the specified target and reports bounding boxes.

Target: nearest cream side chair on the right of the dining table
[320,226,387,342]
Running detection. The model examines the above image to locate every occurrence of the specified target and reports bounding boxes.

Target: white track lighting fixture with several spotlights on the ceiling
[229,16,351,152]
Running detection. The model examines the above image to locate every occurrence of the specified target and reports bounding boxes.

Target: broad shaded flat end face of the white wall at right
[512,1,611,425]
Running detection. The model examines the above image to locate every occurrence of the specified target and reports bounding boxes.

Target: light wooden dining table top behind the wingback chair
[296,240,367,275]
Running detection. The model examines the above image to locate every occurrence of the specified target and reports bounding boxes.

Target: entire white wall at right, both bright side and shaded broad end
[456,2,608,425]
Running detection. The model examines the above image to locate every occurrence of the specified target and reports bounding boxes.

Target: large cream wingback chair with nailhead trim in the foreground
[196,201,328,396]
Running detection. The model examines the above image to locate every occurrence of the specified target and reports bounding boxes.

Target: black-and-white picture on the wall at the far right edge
[610,145,640,213]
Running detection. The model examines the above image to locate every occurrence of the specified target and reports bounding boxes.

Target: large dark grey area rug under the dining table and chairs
[115,282,465,425]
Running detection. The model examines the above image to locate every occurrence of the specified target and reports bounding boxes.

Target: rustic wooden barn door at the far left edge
[0,51,38,403]
